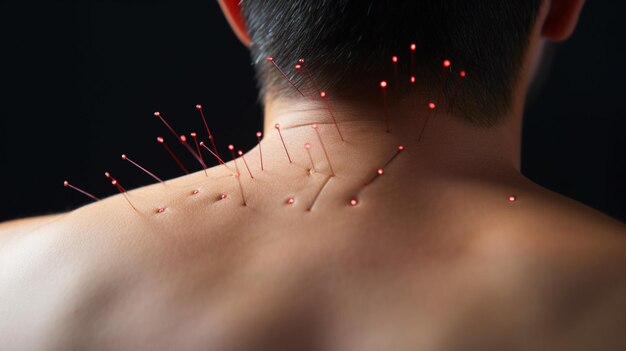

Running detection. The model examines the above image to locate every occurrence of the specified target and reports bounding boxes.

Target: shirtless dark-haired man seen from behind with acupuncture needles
[0,0,626,351]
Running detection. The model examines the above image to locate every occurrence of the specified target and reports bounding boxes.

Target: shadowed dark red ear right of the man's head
[541,0,585,41]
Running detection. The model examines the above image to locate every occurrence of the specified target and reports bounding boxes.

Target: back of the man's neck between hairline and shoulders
[264,94,521,182]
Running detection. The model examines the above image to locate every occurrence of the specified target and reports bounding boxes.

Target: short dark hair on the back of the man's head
[242,0,541,126]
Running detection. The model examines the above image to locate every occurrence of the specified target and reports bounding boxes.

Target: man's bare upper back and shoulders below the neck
[0,166,626,350]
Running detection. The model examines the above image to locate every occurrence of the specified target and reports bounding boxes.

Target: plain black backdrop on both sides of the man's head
[0,0,626,221]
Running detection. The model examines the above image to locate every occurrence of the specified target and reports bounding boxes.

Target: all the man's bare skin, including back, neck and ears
[0,0,626,351]
